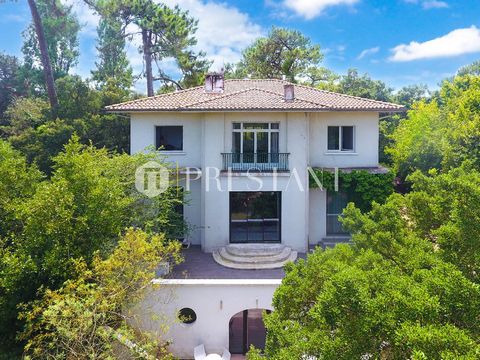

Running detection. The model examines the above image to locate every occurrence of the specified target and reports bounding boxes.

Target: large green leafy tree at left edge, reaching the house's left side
[0,137,187,352]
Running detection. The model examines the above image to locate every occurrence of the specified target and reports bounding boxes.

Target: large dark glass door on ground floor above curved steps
[230,191,281,243]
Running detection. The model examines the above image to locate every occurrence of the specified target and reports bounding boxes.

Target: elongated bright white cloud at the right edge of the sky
[390,25,480,61]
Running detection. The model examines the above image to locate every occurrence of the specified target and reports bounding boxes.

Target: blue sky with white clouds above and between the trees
[0,0,480,90]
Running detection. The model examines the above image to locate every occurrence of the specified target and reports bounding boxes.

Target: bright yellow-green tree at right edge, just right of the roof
[386,75,480,178]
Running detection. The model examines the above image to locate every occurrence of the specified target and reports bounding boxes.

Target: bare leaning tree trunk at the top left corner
[28,0,58,109]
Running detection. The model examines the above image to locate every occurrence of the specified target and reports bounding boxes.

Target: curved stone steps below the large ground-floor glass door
[213,244,297,270]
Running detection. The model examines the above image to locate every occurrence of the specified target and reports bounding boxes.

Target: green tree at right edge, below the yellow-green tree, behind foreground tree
[407,163,480,283]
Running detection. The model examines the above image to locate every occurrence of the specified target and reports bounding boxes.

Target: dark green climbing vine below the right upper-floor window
[309,169,394,211]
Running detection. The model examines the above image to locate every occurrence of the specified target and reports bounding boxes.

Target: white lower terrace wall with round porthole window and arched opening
[136,280,281,359]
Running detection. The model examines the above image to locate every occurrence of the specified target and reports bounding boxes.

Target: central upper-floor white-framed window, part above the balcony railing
[232,123,280,154]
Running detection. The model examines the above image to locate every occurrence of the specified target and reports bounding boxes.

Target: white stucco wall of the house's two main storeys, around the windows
[131,112,378,252]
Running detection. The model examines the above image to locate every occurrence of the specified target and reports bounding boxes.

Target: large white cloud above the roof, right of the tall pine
[162,0,265,69]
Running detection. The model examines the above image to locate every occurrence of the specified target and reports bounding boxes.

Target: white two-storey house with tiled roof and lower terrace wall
[107,73,403,358]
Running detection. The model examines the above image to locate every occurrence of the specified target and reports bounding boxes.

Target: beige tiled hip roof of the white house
[106,80,404,112]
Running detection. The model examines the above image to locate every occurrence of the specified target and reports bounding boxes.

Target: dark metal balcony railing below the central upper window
[222,153,289,171]
